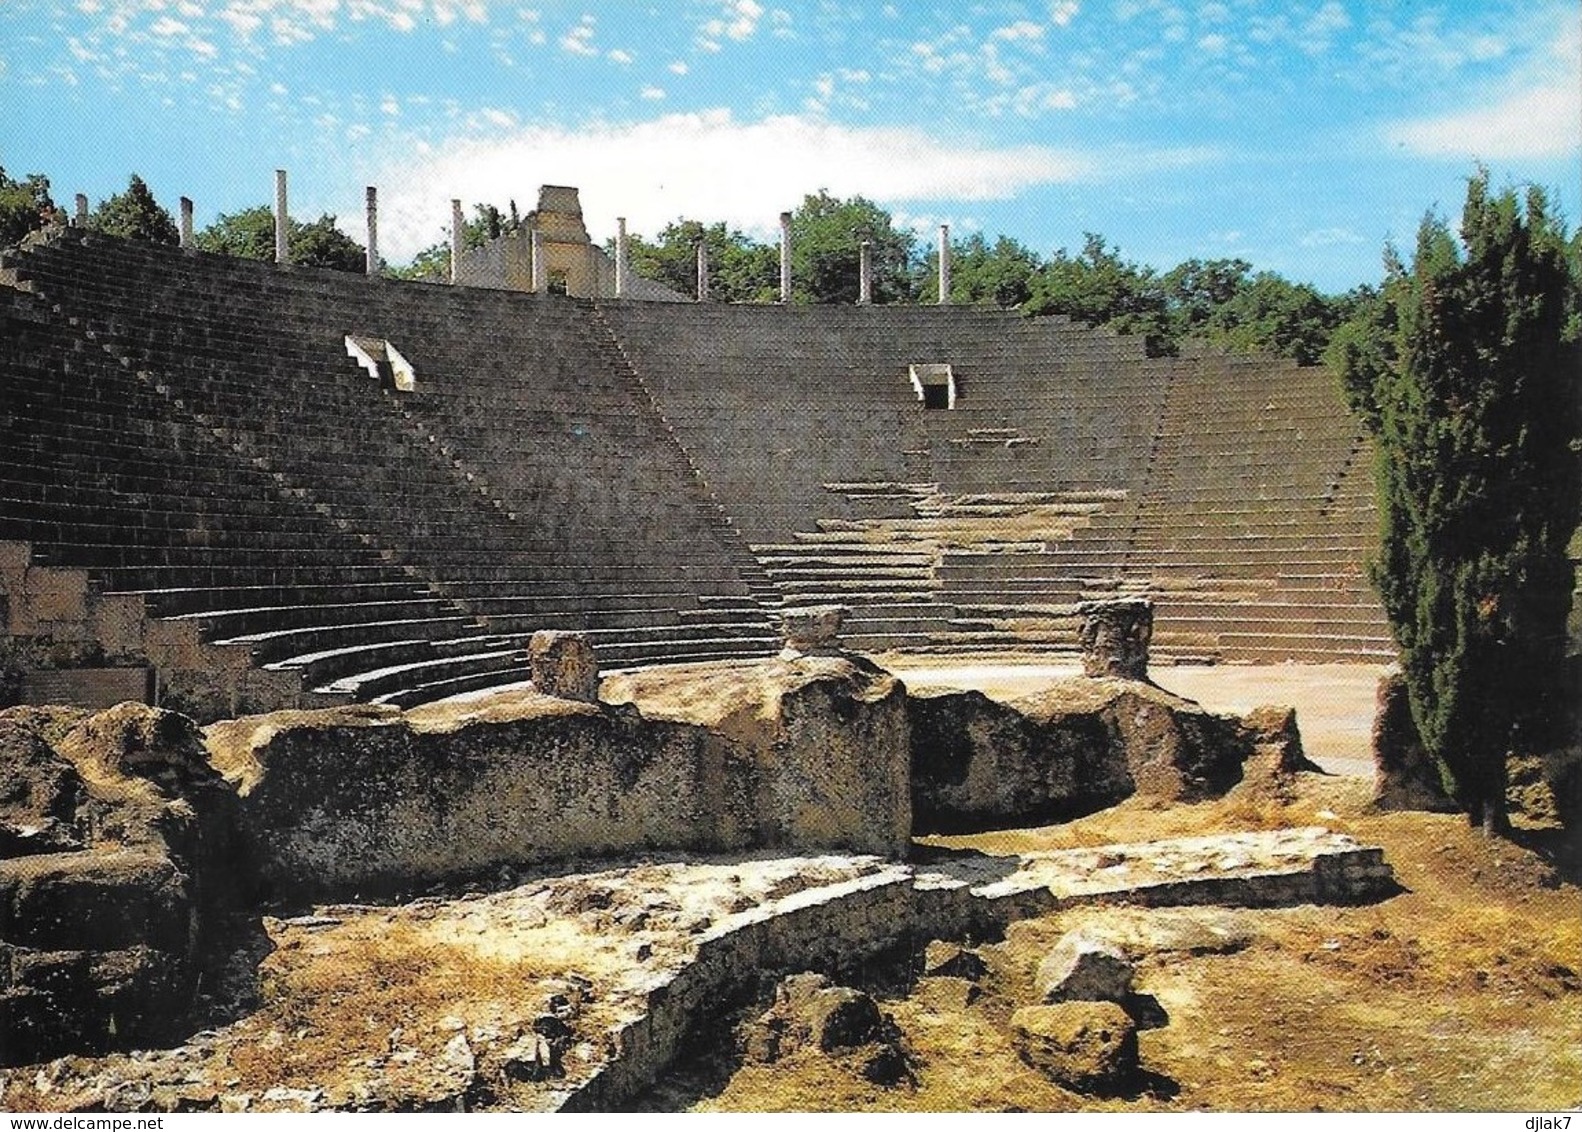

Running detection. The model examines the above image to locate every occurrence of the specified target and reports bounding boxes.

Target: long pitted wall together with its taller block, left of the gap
[209,664,911,896]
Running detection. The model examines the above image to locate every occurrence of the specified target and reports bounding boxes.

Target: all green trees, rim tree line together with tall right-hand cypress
[0,158,1582,832]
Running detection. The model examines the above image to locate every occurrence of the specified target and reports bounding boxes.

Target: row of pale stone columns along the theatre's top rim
[98,169,951,307]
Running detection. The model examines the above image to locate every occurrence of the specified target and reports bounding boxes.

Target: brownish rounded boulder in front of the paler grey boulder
[1011,1002,1141,1094]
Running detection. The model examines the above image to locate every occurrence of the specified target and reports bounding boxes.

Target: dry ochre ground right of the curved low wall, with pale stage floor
[650,658,1582,1111]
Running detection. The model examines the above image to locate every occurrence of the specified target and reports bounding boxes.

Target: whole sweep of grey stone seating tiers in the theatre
[0,237,1376,702]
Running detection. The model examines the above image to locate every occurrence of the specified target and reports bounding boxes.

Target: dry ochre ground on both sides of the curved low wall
[0,658,1582,1111]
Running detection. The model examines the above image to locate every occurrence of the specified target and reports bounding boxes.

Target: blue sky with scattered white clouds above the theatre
[0,0,1582,291]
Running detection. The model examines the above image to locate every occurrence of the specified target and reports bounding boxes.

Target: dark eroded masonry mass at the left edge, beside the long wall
[0,704,247,1062]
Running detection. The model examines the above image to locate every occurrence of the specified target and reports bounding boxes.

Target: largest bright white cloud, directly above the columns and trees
[378,109,1113,258]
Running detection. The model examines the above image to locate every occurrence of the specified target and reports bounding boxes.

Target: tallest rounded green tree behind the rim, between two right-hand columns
[791,190,918,304]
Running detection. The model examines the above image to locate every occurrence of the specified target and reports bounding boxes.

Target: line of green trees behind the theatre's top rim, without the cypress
[9,168,1378,364]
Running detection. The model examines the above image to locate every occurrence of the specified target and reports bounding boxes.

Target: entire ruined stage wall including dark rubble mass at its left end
[0,629,1347,1081]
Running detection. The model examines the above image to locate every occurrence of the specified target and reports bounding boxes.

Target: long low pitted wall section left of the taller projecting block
[210,697,751,895]
